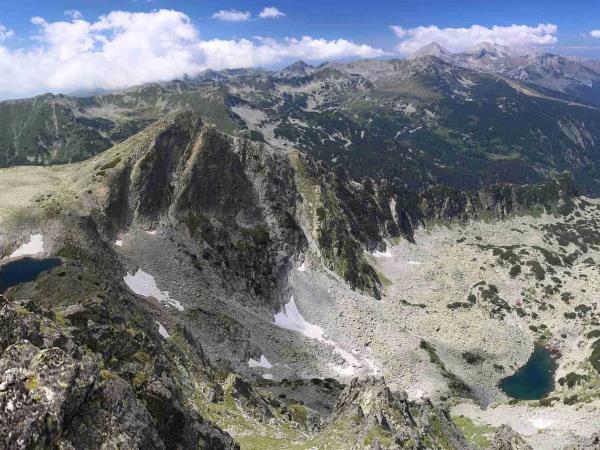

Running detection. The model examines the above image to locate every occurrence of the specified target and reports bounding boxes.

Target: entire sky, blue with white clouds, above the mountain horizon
[0,0,600,99]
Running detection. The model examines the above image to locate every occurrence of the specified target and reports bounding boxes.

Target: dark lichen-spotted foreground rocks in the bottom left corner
[0,296,237,450]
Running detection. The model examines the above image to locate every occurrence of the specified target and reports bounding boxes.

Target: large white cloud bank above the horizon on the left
[0,10,384,99]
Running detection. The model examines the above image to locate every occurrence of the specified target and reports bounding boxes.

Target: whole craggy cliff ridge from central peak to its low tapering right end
[97,113,576,301]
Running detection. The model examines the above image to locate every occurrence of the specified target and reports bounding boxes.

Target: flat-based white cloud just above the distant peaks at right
[392,23,558,55]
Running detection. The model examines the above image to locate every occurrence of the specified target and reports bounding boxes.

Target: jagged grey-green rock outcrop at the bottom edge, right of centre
[329,377,468,449]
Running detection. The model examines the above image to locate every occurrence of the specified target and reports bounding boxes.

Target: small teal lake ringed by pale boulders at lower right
[499,345,556,400]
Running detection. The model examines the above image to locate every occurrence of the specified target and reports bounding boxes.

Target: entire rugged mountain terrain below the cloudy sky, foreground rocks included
[0,33,600,450]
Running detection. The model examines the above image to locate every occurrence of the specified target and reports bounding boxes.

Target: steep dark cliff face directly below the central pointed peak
[100,110,306,299]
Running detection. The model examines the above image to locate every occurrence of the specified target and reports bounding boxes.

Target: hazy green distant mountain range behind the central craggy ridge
[0,43,600,195]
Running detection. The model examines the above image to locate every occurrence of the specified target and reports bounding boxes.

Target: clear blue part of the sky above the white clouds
[0,0,600,54]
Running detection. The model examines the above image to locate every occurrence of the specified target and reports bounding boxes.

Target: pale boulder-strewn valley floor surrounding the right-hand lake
[293,204,600,449]
